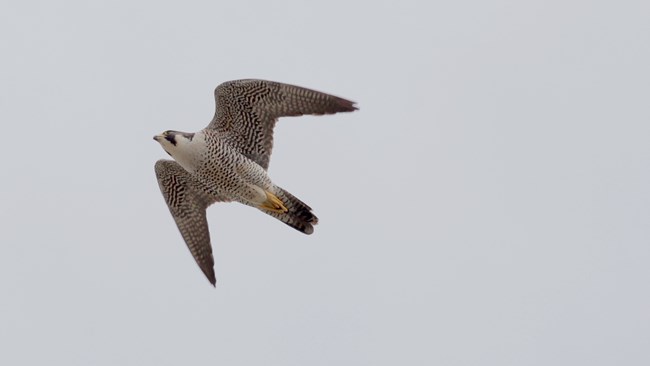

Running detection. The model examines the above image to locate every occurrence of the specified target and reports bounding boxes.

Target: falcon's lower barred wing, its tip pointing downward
[155,160,220,286]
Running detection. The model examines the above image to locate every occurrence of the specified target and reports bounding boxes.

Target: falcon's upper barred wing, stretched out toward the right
[207,79,357,169]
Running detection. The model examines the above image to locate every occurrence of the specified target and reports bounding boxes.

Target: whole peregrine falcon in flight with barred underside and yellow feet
[154,79,357,286]
